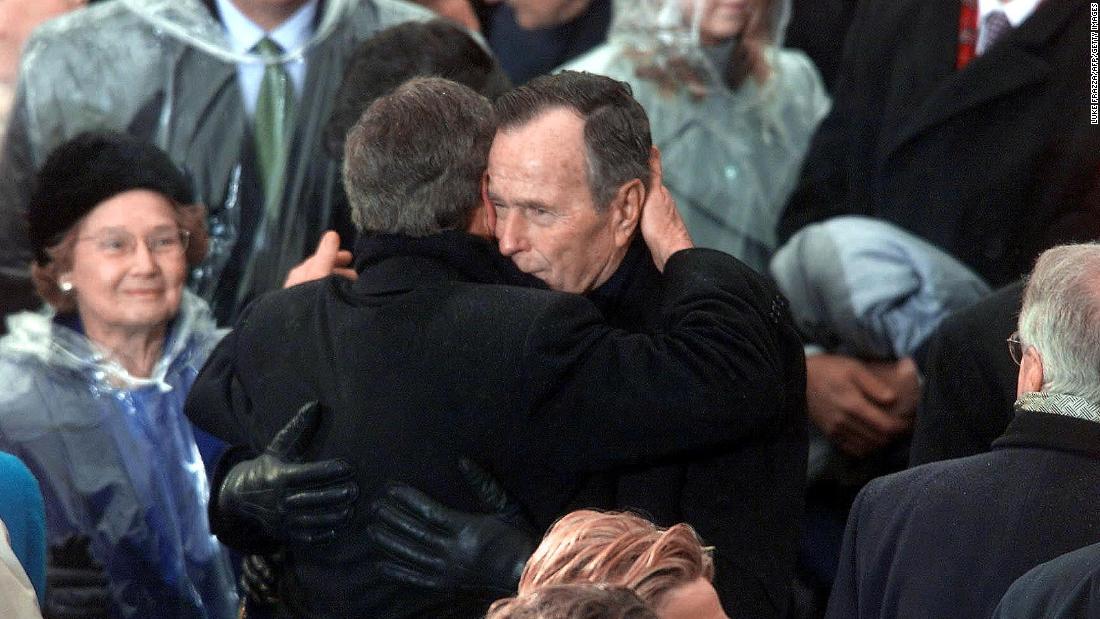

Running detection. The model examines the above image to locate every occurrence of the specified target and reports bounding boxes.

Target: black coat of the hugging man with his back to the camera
[187,233,798,618]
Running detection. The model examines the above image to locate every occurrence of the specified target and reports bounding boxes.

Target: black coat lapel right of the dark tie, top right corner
[884,0,1084,156]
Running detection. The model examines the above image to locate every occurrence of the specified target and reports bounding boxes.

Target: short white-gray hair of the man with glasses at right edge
[1018,243,1100,405]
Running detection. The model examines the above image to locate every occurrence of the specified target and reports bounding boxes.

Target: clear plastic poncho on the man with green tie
[0,0,431,321]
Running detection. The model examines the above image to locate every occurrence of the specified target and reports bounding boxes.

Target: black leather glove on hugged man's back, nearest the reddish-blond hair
[366,461,535,600]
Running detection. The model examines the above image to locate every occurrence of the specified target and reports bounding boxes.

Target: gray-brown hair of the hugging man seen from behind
[343,78,496,236]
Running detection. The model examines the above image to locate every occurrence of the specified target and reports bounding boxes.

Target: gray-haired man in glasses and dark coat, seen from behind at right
[827,243,1100,619]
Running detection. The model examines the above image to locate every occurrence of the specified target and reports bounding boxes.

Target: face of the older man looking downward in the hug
[488,108,635,294]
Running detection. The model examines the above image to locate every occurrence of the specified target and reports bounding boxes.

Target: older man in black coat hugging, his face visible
[365,71,806,619]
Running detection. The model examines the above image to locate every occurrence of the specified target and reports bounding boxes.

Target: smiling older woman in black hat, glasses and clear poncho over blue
[0,134,237,618]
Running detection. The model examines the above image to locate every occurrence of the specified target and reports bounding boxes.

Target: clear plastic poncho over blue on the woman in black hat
[0,292,237,619]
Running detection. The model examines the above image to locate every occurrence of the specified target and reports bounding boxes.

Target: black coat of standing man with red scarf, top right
[779,0,1100,286]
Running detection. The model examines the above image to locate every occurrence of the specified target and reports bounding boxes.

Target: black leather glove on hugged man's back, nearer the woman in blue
[215,401,359,544]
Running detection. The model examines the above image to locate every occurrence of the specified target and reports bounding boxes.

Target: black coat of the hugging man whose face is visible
[590,236,806,619]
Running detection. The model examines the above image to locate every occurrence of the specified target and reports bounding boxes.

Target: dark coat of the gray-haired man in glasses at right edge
[826,411,1100,619]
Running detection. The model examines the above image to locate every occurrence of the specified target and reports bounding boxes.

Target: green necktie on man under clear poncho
[253,36,295,196]
